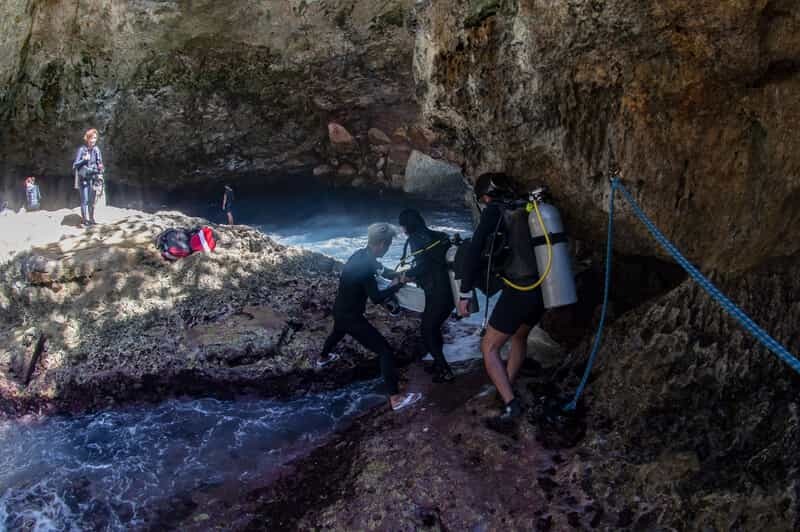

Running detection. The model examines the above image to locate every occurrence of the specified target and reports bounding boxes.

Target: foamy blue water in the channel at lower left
[0,381,385,530]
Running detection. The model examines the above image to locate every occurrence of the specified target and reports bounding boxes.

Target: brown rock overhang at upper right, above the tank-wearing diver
[414,0,800,272]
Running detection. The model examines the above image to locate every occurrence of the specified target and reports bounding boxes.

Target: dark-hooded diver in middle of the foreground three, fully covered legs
[398,209,455,383]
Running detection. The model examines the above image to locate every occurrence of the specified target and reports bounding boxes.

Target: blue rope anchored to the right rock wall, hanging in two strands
[564,178,800,410]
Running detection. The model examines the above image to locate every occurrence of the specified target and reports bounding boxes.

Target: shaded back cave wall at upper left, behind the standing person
[0,0,460,188]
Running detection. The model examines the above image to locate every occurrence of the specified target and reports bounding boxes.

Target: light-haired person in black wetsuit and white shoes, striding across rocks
[317,223,422,410]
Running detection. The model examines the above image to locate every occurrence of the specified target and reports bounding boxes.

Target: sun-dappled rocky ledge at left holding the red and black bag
[0,208,419,415]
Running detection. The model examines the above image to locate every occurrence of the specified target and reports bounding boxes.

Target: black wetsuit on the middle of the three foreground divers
[406,229,455,370]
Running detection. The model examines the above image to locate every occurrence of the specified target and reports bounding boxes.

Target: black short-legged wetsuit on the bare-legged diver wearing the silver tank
[460,203,545,334]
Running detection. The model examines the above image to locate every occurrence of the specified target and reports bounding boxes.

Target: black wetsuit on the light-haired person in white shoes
[322,248,400,395]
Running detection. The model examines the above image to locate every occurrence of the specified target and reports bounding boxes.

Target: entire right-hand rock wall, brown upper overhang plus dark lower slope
[414,0,800,530]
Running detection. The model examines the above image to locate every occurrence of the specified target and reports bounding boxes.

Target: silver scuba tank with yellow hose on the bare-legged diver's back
[528,189,578,308]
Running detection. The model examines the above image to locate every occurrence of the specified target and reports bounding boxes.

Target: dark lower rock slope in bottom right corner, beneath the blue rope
[566,257,800,530]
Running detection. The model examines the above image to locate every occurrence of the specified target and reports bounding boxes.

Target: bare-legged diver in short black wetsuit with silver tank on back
[458,173,545,432]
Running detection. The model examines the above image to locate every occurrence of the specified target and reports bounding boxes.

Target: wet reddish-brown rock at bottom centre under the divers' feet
[170,363,610,530]
